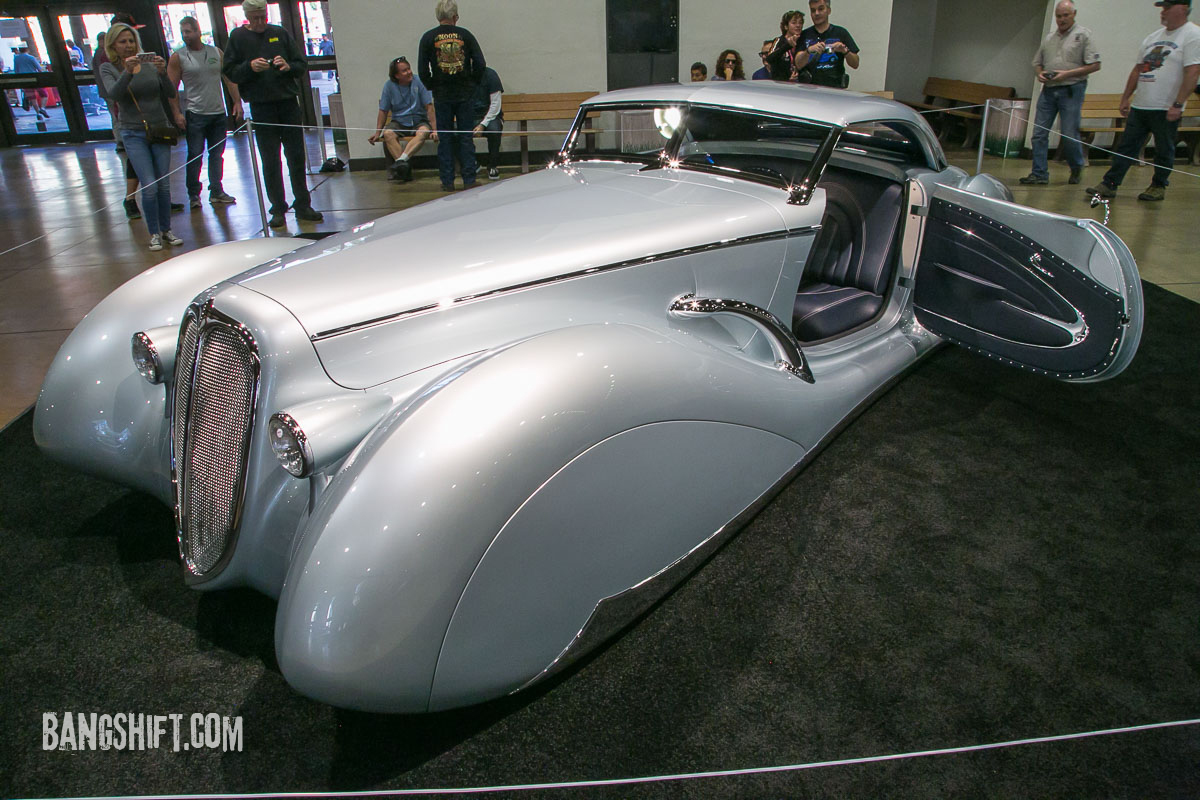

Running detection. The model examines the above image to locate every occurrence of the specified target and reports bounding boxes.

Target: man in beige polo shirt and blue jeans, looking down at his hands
[1021,0,1100,186]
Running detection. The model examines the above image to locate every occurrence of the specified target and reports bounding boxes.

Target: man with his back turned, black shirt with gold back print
[416,0,487,192]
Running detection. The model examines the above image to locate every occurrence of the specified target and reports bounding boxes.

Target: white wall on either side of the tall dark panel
[330,0,892,164]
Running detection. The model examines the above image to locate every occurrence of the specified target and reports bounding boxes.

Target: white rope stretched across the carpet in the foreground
[35,720,1200,800]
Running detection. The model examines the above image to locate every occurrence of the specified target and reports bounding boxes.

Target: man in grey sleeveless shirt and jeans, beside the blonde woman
[167,17,242,209]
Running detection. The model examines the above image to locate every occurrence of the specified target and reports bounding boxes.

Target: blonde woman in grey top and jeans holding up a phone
[100,23,184,251]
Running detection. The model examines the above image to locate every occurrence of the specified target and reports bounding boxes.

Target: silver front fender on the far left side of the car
[34,239,311,503]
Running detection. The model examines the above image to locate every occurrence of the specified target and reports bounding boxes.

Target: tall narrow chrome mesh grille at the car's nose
[172,303,259,577]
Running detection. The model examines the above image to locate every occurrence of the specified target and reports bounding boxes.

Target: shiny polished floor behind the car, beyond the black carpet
[0,134,1200,426]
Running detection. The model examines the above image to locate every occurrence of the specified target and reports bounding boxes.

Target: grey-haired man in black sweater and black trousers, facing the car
[223,0,324,228]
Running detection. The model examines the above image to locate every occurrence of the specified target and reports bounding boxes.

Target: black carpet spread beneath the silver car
[0,285,1200,798]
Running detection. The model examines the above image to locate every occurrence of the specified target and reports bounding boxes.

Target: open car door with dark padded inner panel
[913,186,1142,383]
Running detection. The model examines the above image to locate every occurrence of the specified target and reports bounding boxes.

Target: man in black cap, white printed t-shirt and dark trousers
[1087,0,1200,200]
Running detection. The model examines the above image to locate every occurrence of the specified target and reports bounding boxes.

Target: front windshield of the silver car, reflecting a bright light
[560,103,835,188]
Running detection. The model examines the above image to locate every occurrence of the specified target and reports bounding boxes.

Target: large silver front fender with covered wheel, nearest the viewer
[275,325,808,712]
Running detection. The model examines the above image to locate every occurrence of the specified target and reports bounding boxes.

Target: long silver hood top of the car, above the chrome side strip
[235,164,784,337]
